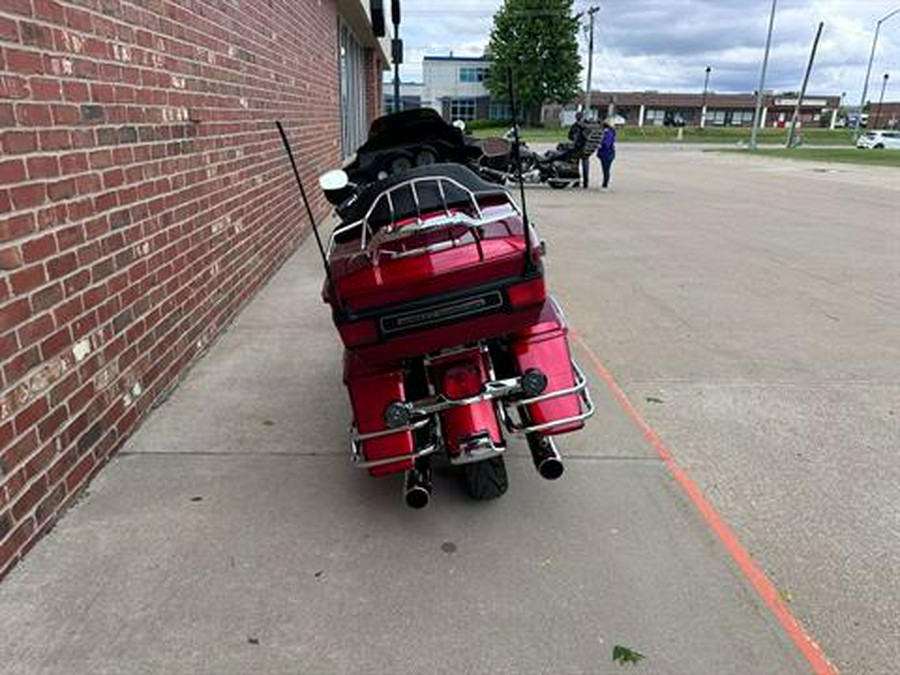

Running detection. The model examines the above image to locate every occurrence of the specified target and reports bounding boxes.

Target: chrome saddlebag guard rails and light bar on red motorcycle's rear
[350,360,595,469]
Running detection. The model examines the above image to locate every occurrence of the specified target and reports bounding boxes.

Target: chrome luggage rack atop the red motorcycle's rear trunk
[328,176,519,260]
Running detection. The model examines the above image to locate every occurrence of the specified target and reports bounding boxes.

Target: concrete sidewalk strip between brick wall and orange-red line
[0,239,809,675]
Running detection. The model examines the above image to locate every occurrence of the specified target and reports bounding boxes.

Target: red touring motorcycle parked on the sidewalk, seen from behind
[285,110,594,508]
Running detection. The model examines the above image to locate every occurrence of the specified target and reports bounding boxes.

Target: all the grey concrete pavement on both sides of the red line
[0,146,900,675]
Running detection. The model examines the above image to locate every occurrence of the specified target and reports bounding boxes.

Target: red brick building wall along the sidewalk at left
[0,0,386,578]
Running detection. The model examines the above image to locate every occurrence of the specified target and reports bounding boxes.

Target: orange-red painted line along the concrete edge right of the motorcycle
[570,330,838,675]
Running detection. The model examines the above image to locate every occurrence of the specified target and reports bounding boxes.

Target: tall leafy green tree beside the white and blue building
[485,0,581,123]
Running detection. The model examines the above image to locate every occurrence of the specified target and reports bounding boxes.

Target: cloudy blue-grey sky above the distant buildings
[394,0,900,103]
